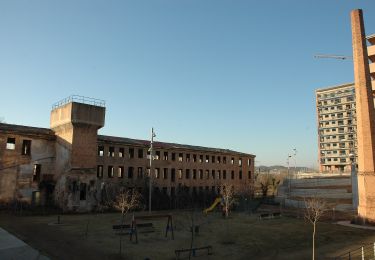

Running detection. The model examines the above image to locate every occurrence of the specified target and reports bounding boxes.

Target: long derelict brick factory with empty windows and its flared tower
[0,96,255,210]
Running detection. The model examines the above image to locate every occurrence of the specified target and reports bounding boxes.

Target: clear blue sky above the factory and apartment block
[0,0,375,167]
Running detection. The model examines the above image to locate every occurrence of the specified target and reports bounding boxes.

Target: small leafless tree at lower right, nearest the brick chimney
[305,197,327,260]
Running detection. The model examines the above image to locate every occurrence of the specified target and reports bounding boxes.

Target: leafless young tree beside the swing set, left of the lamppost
[113,188,141,255]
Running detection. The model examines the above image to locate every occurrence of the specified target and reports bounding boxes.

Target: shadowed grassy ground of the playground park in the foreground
[0,211,375,260]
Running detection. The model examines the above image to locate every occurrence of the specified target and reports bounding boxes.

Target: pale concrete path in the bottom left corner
[0,228,49,260]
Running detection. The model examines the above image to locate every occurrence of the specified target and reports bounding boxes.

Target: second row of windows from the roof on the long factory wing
[97,165,251,182]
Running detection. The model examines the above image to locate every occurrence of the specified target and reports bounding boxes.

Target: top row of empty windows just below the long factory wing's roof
[98,146,251,166]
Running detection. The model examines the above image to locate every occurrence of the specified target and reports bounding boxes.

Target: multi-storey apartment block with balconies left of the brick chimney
[315,83,357,172]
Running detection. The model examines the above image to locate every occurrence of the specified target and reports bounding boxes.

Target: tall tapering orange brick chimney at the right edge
[351,10,375,222]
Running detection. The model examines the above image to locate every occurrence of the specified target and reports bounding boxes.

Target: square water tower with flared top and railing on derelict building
[50,96,105,211]
